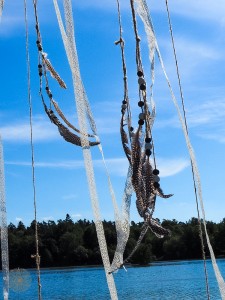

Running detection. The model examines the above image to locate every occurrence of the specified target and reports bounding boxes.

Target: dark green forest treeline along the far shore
[4,214,225,269]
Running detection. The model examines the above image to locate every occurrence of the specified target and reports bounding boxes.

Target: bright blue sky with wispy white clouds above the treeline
[0,0,225,224]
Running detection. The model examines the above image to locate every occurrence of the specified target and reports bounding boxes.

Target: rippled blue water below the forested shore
[0,259,225,300]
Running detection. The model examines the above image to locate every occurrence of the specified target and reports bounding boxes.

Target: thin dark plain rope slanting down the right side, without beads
[165,0,210,300]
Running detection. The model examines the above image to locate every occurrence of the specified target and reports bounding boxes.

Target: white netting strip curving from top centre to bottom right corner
[135,0,225,300]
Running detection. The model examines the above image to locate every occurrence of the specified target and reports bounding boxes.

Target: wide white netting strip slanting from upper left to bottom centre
[53,0,118,299]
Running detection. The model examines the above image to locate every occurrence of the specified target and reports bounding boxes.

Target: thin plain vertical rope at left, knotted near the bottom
[24,0,42,300]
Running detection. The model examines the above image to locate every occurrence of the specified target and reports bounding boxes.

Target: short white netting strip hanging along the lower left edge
[0,138,9,300]
